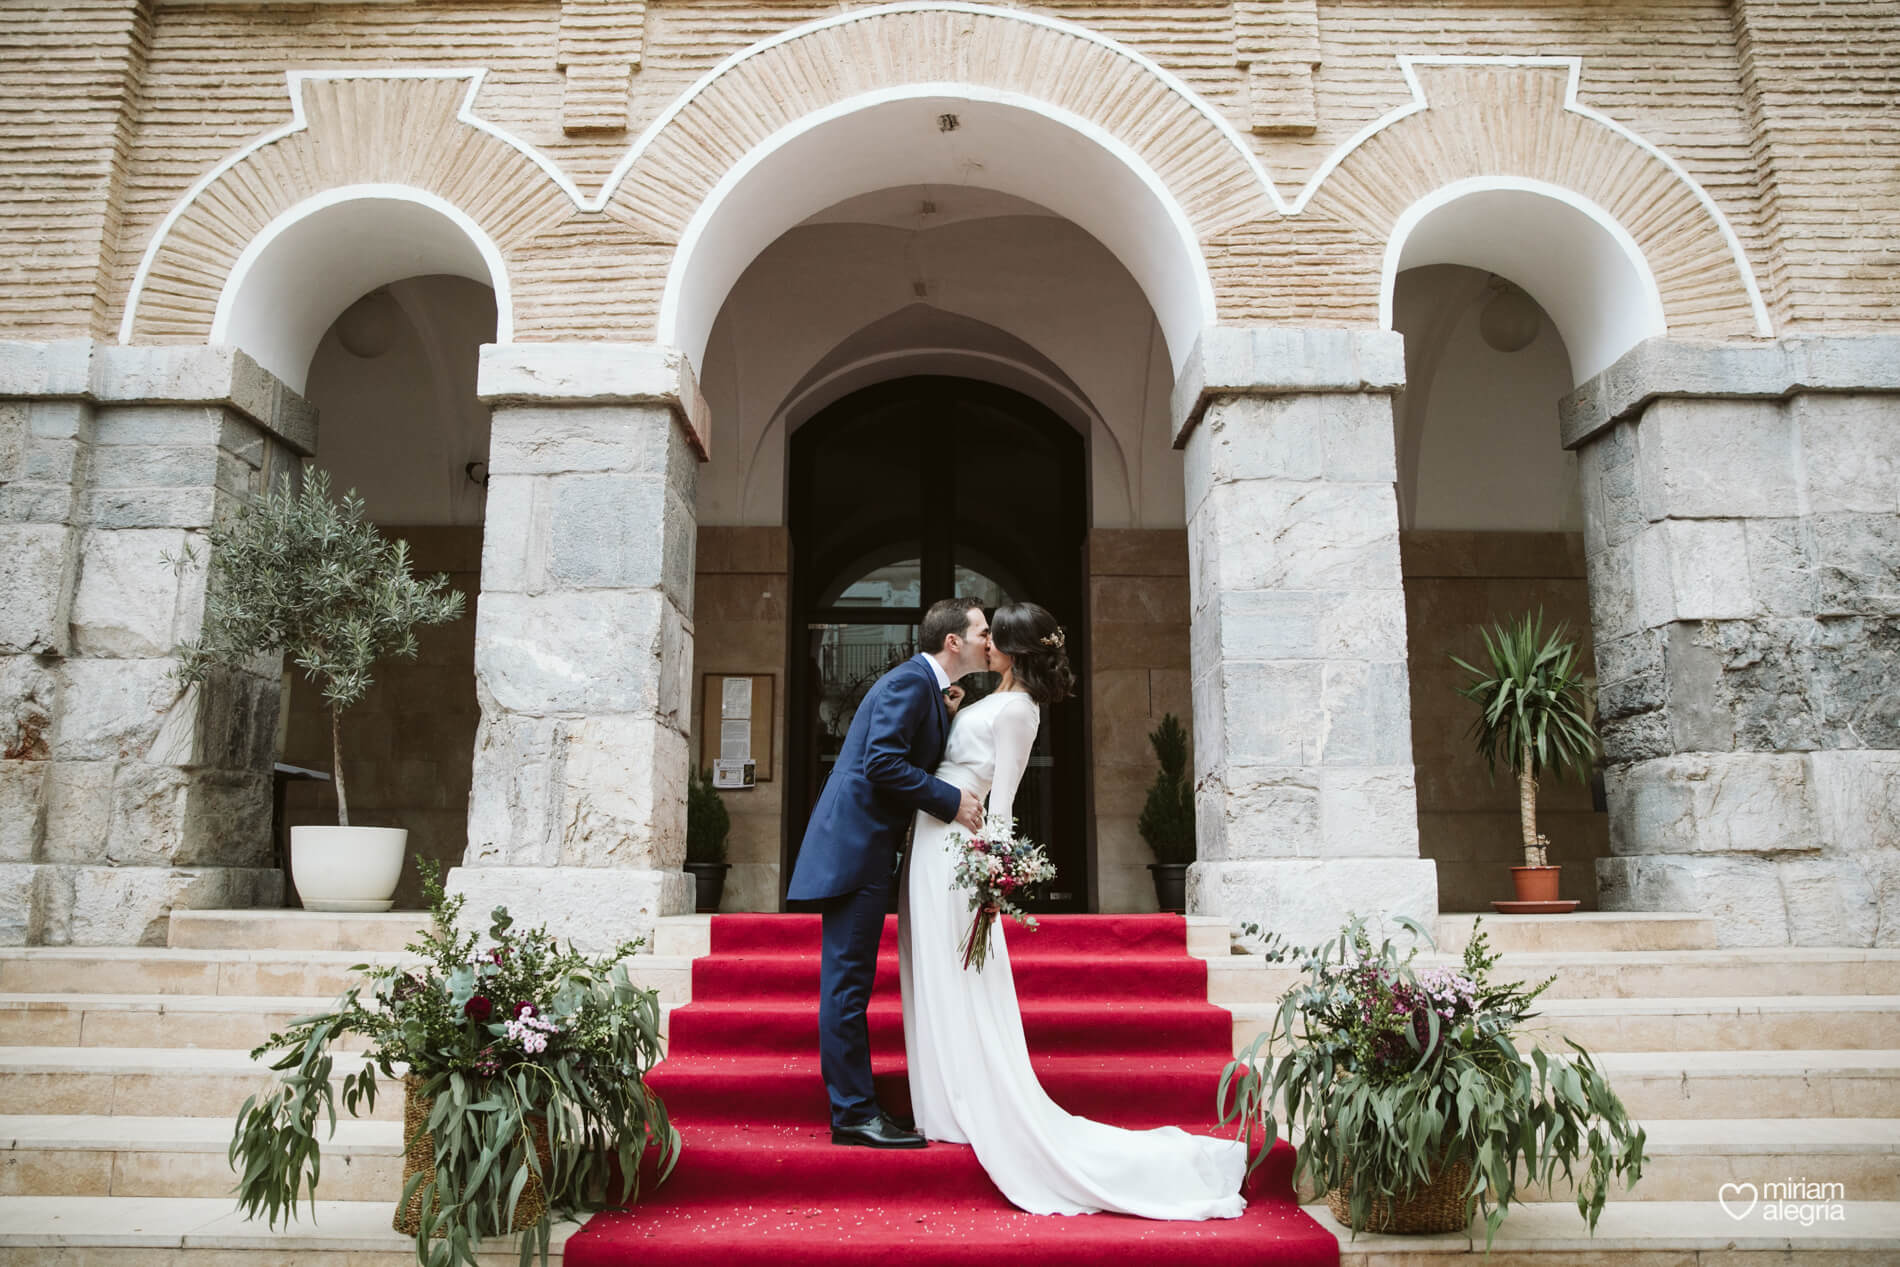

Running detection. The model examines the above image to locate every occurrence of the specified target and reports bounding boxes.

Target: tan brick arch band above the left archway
[120,70,580,344]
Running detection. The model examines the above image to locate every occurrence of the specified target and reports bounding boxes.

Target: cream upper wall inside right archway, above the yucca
[1393,264,1583,532]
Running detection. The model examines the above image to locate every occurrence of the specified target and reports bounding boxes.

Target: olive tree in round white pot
[179,471,464,910]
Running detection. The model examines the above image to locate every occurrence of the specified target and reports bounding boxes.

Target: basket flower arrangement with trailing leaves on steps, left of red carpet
[230,860,680,1267]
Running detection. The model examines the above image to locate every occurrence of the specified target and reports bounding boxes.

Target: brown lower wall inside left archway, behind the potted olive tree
[283,524,481,910]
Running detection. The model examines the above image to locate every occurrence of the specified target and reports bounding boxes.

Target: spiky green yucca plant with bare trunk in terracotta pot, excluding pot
[1452,612,1598,866]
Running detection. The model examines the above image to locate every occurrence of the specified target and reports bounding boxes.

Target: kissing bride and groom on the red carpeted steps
[787,598,1246,1220]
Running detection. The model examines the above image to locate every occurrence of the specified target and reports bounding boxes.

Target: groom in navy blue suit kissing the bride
[785,598,990,1147]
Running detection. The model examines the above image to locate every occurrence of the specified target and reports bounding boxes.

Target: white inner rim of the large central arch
[654,81,1220,369]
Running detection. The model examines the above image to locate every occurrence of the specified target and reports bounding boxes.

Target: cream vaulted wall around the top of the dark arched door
[699,186,1184,528]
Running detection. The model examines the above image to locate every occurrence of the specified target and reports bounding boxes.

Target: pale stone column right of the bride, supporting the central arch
[1174,327,1438,944]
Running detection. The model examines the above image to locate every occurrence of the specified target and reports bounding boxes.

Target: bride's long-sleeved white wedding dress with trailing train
[897,691,1246,1220]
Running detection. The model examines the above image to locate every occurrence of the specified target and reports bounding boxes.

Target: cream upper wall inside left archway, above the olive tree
[306,275,496,526]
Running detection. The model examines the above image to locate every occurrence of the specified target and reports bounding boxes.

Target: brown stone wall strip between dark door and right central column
[1083,528,1193,912]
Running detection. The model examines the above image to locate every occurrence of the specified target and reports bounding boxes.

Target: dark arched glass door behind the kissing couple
[781,378,1091,910]
